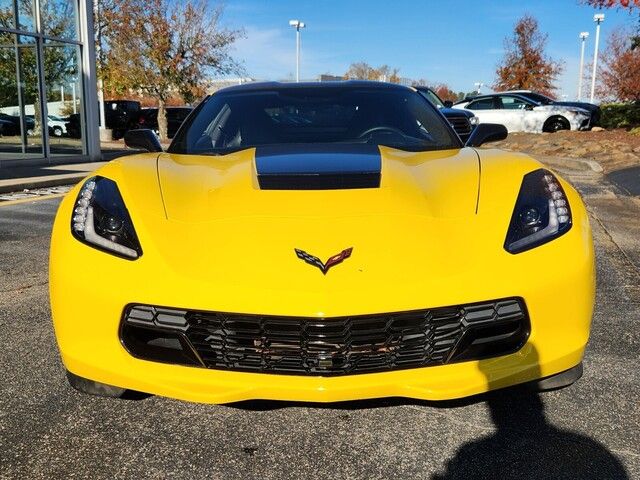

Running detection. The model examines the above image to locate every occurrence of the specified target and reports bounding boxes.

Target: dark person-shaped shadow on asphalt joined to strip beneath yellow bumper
[227,348,629,480]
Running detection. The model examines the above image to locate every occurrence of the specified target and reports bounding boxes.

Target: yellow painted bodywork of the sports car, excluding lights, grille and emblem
[50,147,595,403]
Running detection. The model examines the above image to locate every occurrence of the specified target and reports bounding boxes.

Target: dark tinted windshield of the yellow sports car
[169,87,460,154]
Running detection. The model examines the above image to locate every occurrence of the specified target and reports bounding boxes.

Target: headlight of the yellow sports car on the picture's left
[71,177,142,260]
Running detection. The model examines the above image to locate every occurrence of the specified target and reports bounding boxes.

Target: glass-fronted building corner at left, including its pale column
[0,0,100,169]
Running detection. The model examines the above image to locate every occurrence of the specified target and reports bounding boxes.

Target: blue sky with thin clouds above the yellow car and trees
[223,0,637,98]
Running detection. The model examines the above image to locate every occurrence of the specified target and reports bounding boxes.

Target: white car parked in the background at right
[454,93,591,133]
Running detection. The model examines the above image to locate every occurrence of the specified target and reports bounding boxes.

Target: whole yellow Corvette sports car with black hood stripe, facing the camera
[50,81,594,403]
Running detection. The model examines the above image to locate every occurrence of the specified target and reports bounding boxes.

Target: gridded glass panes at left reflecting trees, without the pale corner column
[0,0,86,160]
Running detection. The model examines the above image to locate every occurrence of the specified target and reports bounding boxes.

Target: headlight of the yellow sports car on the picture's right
[504,168,571,253]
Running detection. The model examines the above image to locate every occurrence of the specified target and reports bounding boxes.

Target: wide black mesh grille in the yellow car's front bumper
[122,299,529,375]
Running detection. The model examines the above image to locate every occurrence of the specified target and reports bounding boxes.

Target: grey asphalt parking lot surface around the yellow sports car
[0,158,640,479]
